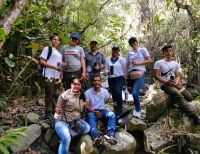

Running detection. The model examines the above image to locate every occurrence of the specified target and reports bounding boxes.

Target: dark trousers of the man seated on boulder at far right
[161,84,198,118]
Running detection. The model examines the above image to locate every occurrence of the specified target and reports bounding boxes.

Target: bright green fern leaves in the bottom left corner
[0,127,26,154]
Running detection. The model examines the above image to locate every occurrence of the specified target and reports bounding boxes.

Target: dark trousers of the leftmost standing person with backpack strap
[45,79,61,113]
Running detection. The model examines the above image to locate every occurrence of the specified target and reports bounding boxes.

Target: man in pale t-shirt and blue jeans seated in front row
[85,76,117,146]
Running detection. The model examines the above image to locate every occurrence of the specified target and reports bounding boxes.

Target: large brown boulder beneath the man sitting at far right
[146,91,171,122]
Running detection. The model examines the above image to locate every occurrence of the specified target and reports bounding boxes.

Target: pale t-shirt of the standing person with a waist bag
[126,48,149,71]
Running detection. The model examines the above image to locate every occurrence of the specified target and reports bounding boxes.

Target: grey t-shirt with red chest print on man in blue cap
[61,46,85,72]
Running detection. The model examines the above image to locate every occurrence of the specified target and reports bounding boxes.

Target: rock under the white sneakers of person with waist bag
[126,118,147,132]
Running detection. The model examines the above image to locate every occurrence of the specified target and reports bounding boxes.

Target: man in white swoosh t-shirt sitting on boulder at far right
[153,45,200,125]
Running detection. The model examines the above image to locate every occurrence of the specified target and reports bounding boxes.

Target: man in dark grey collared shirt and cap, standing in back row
[85,39,106,89]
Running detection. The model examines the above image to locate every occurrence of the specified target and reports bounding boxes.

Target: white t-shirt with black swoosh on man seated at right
[153,59,182,80]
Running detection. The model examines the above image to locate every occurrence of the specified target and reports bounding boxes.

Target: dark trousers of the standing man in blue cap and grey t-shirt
[63,70,82,90]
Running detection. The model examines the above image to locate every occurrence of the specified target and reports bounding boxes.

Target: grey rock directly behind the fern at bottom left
[10,124,42,153]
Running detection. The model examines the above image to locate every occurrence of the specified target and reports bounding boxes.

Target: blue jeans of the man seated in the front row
[88,109,116,139]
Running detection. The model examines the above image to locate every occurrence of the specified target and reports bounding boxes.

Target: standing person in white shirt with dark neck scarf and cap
[105,45,126,116]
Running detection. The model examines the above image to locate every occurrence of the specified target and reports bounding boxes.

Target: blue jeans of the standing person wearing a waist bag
[132,75,145,112]
